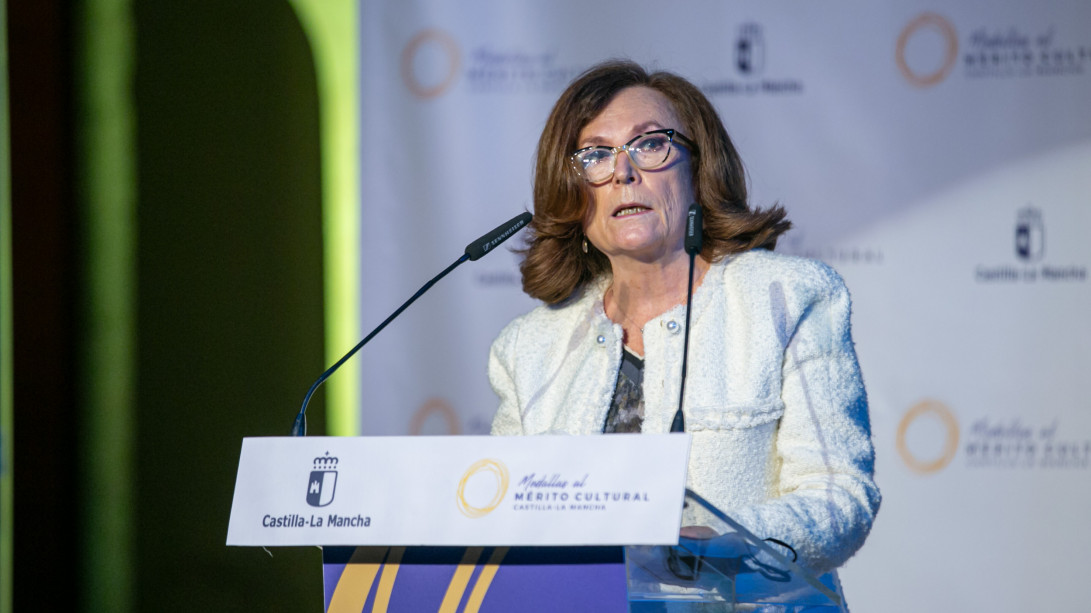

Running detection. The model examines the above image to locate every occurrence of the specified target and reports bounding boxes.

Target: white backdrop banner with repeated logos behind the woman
[356,0,1091,612]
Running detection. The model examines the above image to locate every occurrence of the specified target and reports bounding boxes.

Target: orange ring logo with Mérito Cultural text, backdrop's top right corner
[895,13,1091,88]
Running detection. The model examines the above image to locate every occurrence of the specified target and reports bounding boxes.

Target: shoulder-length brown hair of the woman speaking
[519,60,791,304]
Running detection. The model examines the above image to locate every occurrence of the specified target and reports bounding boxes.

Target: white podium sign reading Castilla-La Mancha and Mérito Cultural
[227,434,690,546]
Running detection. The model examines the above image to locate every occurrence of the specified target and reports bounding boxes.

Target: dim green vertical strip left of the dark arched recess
[75,0,137,611]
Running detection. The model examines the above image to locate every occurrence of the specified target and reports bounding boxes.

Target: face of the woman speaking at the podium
[577,86,694,265]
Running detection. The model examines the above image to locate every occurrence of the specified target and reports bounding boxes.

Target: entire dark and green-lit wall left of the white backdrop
[0,0,358,613]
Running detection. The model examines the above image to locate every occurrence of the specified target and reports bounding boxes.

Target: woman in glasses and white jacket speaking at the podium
[489,61,879,572]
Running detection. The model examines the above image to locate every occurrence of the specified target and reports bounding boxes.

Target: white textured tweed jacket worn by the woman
[489,250,879,572]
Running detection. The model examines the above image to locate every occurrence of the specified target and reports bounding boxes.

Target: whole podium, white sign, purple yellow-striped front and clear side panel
[228,434,846,613]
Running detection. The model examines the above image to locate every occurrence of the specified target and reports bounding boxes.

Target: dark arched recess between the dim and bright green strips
[129,0,326,612]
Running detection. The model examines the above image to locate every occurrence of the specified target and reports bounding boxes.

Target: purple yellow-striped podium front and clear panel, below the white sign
[322,491,846,613]
